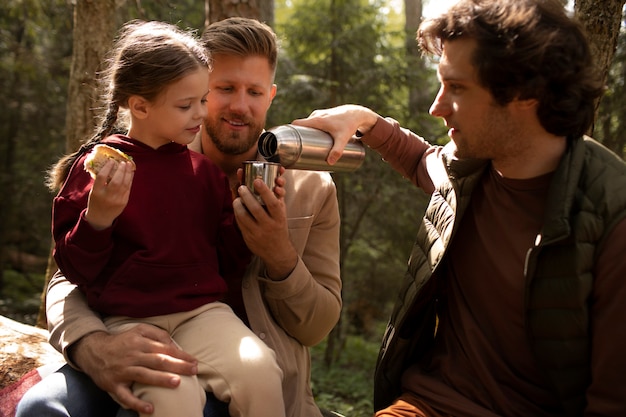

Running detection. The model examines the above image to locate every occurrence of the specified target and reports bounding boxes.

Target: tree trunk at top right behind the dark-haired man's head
[574,0,626,134]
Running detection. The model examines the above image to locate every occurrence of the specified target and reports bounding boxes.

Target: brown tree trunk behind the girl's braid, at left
[37,0,117,328]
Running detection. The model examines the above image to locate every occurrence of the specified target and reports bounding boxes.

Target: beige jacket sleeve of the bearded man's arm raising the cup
[259,173,341,346]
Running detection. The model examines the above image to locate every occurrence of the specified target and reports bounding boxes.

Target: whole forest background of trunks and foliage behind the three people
[0,0,626,417]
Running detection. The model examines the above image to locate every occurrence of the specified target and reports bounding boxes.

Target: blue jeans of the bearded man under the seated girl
[15,365,229,417]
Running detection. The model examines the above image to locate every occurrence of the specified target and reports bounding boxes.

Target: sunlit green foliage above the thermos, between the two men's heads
[269,0,403,125]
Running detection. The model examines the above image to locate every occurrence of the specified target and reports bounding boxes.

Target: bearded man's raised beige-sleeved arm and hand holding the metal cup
[233,170,341,346]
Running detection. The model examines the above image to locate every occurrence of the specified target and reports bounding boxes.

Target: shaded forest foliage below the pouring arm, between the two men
[334,151,428,337]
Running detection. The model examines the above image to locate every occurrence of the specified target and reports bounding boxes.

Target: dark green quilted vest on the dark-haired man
[374,137,626,416]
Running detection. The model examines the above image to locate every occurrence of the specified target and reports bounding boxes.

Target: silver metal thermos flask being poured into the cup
[258,124,365,172]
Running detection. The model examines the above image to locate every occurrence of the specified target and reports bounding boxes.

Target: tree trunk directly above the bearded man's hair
[205,0,274,26]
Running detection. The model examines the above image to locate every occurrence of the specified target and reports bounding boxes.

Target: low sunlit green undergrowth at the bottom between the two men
[311,336,380,417]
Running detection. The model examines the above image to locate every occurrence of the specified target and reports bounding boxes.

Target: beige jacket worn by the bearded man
[46,154,341,417]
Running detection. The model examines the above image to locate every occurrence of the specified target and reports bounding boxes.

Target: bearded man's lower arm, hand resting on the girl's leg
[46,272,197,413]
